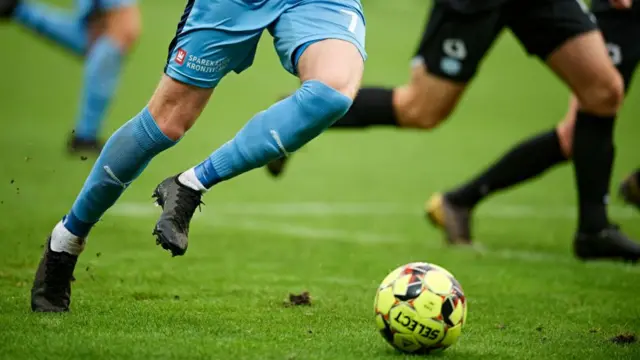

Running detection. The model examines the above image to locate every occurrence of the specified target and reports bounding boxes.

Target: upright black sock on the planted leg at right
[573,111,615,232]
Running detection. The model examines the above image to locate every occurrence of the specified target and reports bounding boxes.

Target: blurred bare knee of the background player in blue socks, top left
[106,7,142,52]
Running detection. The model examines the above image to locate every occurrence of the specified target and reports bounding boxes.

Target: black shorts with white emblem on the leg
[416,0,597,82]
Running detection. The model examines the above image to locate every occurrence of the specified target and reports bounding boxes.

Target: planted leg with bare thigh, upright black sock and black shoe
[547,31,640,261]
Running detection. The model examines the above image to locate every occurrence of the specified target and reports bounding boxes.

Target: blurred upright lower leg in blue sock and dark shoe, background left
[73,0,140,152]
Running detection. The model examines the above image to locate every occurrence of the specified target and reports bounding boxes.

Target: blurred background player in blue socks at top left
[0,0,141,153]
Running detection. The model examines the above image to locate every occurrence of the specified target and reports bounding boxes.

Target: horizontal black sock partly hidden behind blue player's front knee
[331,88,398,129]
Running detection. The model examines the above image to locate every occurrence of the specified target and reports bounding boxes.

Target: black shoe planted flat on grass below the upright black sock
[573,225,640,263]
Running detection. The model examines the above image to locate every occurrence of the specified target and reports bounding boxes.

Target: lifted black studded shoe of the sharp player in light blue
[153,175,202,256]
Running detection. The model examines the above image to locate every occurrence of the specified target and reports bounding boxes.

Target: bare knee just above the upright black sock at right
[579,73,624,115]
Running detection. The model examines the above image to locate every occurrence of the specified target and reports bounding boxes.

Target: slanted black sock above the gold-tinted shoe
[446,129,567,207]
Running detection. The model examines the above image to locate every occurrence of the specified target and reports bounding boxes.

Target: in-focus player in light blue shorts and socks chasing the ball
[31,0,366,312]
